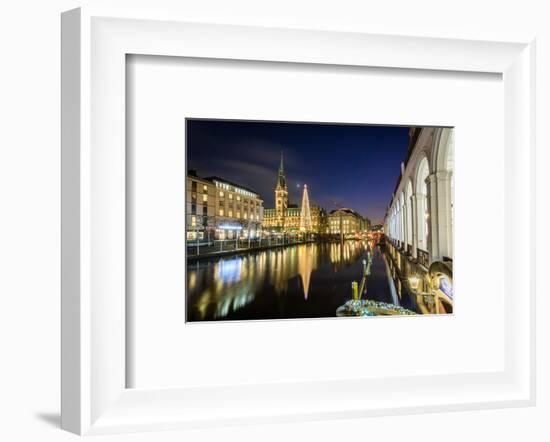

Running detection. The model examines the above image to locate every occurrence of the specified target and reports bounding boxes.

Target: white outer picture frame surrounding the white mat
[62,5,535,434]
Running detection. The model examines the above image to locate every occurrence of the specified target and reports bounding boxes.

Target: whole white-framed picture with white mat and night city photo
[62,9,535,434]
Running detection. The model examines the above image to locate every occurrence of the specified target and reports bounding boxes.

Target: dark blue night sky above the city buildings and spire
[187,120,409,223]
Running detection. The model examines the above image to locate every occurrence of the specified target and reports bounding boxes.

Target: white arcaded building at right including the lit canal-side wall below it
[384,128,454,312]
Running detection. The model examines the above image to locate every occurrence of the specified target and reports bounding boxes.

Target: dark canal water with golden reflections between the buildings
[187,240,414,321]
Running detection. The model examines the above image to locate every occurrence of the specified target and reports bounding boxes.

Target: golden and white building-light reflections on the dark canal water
[191,240,380,321]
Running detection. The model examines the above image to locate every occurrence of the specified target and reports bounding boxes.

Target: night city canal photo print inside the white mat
[186,119,454,322]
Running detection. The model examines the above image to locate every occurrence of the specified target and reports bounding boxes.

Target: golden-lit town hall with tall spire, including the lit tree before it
[262,153,328,234]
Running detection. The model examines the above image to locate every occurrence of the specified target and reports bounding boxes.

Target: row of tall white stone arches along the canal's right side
[384,128,454,263]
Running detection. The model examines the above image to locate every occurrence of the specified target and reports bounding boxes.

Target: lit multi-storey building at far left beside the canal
[186,170,263,240]
